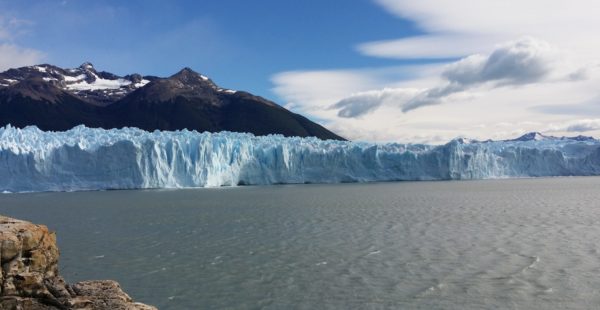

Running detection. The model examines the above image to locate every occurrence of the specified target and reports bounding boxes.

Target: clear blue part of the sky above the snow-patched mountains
[0,0,418,97]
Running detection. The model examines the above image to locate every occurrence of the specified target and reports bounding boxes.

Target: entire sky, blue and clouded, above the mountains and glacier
[0,0,600,144]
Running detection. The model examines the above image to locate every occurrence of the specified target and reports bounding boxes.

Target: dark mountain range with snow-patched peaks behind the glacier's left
[0,63,343,140]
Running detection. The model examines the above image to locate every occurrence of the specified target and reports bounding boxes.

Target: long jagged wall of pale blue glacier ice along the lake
[0,126,600,192]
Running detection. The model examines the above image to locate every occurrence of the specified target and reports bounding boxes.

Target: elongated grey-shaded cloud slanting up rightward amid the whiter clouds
[333,37,568,117]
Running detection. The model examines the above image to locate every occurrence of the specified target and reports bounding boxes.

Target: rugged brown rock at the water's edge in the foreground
[0,215,156,310]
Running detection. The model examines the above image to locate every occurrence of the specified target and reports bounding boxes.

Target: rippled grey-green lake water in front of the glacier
[0,177,600,309]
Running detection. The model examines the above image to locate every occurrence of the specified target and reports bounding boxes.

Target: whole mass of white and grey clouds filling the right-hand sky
[273,0,600,142]
